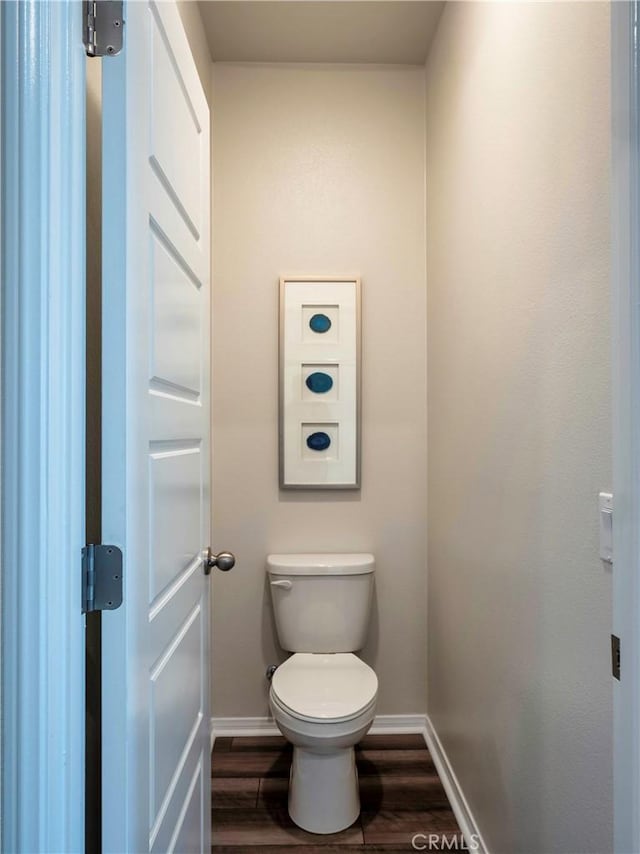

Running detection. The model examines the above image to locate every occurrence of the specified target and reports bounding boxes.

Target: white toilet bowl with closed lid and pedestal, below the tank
[269,653,378,833]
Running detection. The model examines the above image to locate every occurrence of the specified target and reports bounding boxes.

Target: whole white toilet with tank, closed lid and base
[267,553,378,833]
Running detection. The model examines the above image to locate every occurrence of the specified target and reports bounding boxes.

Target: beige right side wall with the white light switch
[427,2,612,854]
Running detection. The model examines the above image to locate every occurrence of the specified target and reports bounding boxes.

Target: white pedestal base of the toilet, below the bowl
[289,747,360,833]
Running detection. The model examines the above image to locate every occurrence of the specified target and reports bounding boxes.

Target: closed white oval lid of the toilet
[271,652,378,720]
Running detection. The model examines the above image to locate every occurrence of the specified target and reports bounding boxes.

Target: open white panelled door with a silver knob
[102,2,210,854]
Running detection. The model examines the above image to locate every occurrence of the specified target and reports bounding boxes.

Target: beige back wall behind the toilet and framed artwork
[212,64,426,716]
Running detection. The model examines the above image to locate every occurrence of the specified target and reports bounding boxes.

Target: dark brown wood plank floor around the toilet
[211,735,463,854]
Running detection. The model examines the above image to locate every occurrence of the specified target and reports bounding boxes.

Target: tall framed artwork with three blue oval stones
[280,276,361,489]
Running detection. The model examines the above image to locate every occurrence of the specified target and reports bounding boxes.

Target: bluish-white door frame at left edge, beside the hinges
[0,0,86,852]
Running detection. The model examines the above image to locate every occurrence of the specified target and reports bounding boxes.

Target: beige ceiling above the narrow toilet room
[199,0,444,65]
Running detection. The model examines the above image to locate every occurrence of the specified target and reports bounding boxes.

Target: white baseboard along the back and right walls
[211,715,489,854]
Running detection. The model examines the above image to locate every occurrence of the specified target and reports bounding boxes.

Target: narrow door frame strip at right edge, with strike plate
[603,0,640,854]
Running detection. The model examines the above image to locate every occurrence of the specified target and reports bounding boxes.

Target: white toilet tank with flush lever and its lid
[267,553,375,652]
